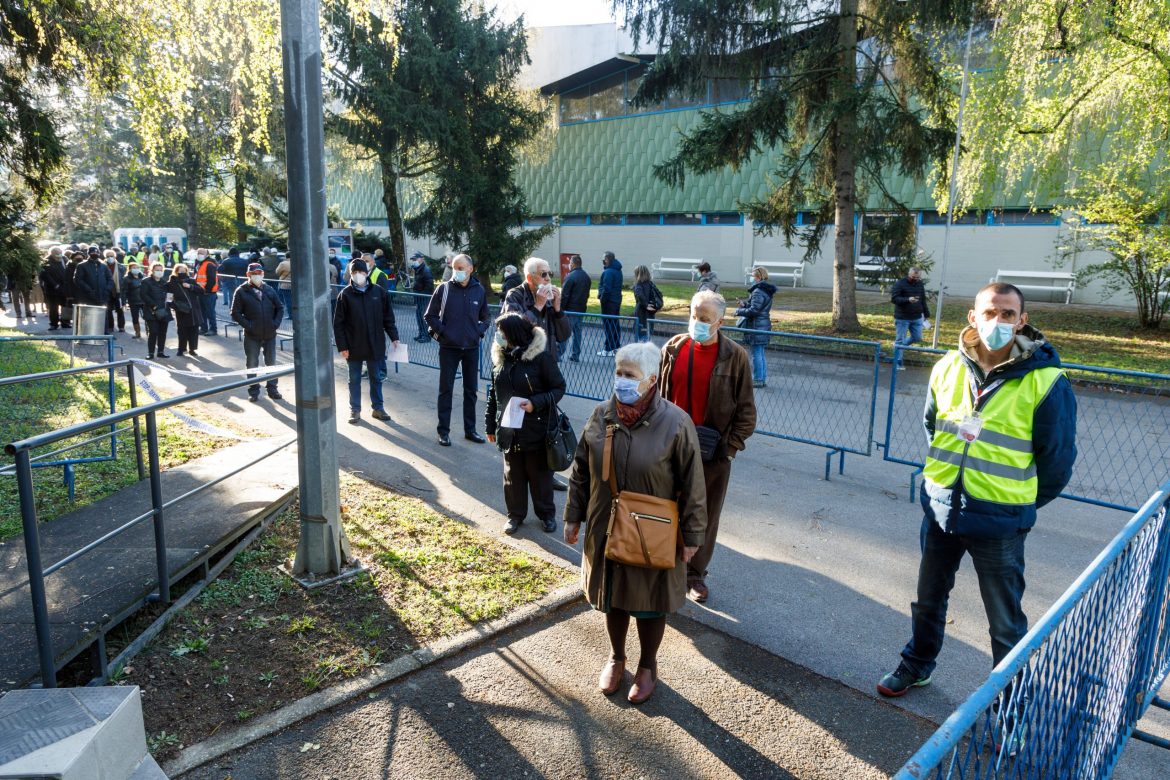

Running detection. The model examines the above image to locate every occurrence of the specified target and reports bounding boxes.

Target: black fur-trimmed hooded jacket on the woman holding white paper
[483,327,565,450]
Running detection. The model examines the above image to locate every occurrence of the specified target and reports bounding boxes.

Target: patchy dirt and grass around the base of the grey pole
[118,476,573,760]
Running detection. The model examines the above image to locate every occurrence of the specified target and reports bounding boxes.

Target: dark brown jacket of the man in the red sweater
[659,333,756,458]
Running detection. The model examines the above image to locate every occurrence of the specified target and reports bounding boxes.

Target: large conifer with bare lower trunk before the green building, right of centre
[615,0,975,333]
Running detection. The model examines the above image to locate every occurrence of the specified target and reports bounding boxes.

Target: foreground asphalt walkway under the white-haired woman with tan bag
[183,606,934,780]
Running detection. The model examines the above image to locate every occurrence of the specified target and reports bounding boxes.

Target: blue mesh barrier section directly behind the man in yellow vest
[879,347,1170,512]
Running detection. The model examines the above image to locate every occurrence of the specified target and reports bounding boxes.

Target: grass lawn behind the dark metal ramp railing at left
[0,331,246,539]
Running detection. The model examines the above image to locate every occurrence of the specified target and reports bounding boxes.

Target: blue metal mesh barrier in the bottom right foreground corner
[896,482,1170,780]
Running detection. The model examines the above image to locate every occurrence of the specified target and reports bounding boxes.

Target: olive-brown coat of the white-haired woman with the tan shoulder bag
[565,398,707,612]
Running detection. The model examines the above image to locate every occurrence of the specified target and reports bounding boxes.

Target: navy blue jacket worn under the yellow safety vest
[920,325,1076,538]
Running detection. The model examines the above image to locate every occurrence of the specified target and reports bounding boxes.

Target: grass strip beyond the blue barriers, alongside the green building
[570,282,1170,374]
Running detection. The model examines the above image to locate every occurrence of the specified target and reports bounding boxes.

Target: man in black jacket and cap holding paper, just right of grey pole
[333,260,398,424]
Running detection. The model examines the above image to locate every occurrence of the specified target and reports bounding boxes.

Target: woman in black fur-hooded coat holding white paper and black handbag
[484,313,565,534]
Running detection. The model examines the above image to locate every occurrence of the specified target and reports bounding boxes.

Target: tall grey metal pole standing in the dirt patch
[281,0,349,575]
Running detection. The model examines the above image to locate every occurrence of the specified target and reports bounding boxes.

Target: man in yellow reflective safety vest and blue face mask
[878,282,1076,696]
